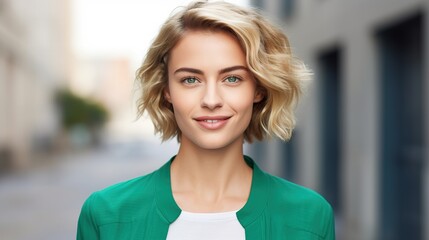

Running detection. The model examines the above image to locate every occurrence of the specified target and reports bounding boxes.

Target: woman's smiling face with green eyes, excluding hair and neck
[165,31,262,149]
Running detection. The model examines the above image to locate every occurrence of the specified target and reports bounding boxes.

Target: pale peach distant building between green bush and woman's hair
[70,56,138,139]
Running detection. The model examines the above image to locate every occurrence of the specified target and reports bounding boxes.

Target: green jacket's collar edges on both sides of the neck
[155,156,269,228]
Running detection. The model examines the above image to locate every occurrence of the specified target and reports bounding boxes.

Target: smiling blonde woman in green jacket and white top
[77,1,335,240]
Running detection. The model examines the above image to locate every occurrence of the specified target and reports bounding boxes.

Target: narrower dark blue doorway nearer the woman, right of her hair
[318,48,342,214]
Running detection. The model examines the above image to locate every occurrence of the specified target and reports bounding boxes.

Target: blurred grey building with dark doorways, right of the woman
[249,0,429,240]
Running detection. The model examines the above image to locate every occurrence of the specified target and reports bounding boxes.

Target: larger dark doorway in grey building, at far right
[377,15,424,240]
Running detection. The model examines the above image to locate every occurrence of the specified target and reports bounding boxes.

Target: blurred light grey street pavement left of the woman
[0,140,177,240]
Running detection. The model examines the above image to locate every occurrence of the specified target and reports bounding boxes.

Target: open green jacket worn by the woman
[77,156,335,240]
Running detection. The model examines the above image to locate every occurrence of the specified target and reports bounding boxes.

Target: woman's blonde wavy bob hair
[137,1,311,142]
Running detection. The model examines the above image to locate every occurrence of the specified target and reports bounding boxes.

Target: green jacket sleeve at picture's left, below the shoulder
[76,194,100,240]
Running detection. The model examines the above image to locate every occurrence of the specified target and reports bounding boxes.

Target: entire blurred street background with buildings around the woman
[0,0,429,240]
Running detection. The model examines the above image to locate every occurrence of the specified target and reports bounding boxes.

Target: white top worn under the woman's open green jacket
[167,211,246,240]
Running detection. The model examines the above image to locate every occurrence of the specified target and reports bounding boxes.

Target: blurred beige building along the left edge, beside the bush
[0,0,69,169]
